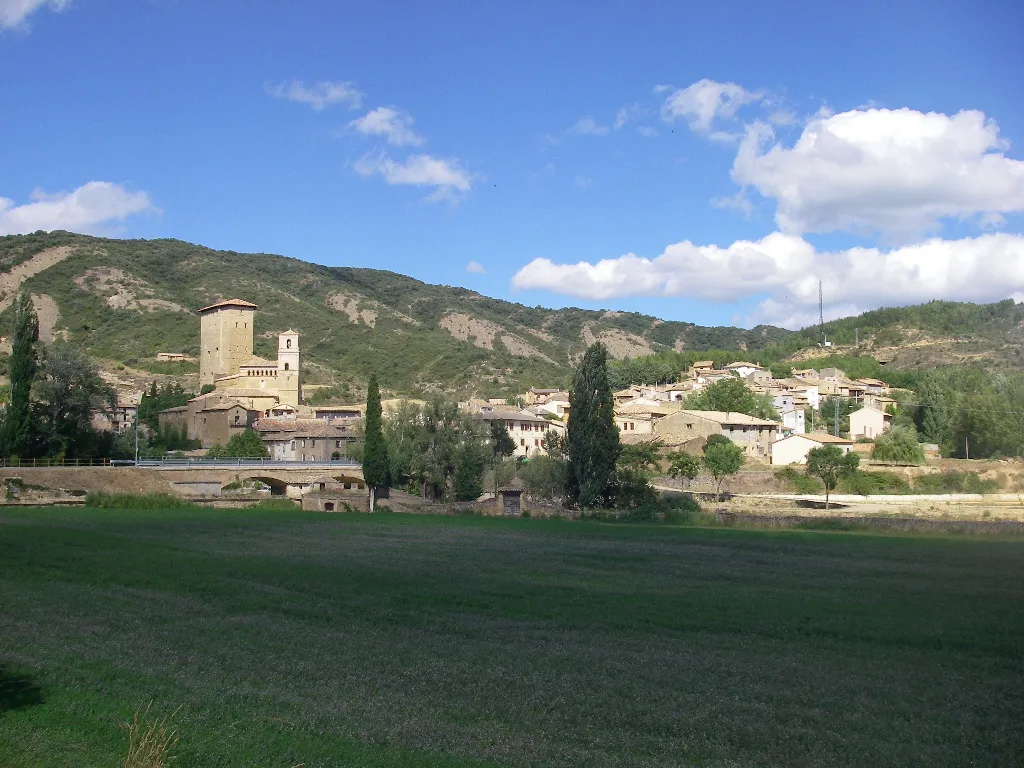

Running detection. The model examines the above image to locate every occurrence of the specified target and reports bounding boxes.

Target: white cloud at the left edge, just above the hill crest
[0,181,157,234]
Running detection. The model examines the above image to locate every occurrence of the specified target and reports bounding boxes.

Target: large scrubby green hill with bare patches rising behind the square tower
[0,231,790,396]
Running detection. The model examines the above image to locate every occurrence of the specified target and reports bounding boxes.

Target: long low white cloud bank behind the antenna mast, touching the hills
[512,232,1024,327]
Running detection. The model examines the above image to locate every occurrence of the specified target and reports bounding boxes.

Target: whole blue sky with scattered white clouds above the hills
[0,0,1024,327]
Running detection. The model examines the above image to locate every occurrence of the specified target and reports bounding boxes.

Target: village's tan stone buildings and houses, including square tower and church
[88,299,896,464]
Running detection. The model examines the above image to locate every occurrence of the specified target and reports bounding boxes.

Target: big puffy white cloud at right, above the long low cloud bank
[732,109,1024,241]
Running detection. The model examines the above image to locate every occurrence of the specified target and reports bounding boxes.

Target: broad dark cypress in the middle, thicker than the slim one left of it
[567,342,621,508]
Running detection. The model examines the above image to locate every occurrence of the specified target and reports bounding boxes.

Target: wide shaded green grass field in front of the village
[0,509,1024,768]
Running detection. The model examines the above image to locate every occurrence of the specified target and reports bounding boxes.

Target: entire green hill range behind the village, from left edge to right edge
[0,231,1024,396]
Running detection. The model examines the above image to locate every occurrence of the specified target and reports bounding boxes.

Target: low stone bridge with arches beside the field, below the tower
[148,462,365,499]
